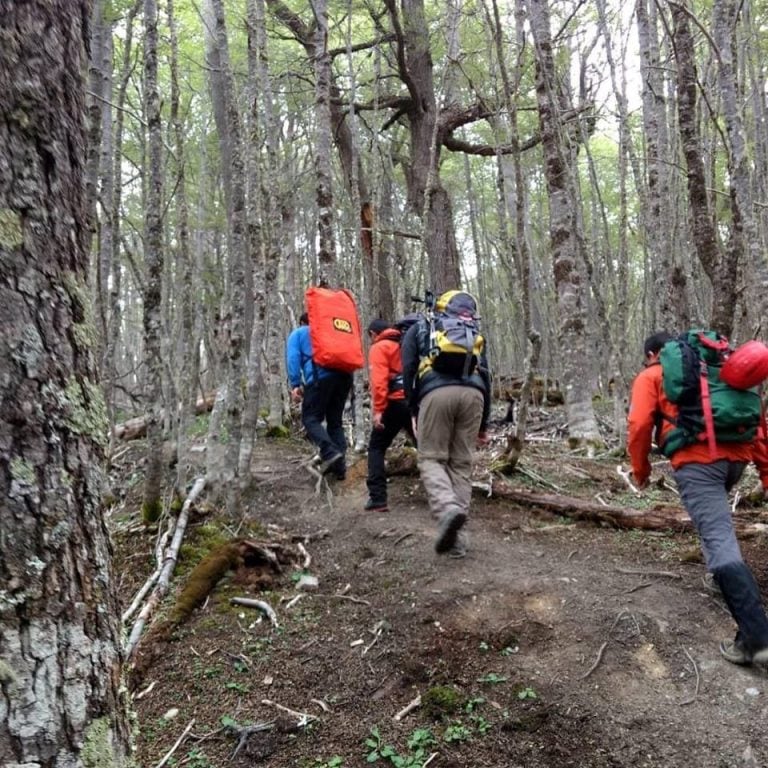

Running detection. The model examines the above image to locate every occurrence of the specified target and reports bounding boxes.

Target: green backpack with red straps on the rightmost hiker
[659,329,762,457]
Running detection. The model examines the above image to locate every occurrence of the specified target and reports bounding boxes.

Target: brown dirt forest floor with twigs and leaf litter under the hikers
[111,404,768,768]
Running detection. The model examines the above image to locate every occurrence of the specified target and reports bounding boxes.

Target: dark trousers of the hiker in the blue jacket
[301,372,352,472]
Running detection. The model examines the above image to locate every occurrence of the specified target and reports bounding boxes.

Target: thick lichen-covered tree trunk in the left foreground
[0,0,129,768]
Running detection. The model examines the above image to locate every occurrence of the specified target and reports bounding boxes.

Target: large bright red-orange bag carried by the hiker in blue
[304,286,365,373]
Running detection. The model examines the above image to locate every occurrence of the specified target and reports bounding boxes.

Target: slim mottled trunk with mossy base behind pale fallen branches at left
[142,0,163,523]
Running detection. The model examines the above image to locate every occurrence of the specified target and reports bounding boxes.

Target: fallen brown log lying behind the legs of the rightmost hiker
[491,477,768,537]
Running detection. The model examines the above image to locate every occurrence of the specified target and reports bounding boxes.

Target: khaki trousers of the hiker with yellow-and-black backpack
[417,385,483,517]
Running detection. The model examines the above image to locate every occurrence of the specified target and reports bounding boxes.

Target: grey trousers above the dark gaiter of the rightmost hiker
[675,459,745,573]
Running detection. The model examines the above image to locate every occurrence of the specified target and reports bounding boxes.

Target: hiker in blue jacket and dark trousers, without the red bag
[285,312,352,480]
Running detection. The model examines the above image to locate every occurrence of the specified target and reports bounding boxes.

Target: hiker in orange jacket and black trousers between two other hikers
[364,320,416,512]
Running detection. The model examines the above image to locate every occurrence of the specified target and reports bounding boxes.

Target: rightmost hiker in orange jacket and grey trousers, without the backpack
[627,333,768,665]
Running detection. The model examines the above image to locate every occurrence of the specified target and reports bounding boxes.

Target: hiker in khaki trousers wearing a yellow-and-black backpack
[402,291,491,557]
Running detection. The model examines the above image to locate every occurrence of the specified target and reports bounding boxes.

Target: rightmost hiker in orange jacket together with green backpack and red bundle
[627,330,768,665]
